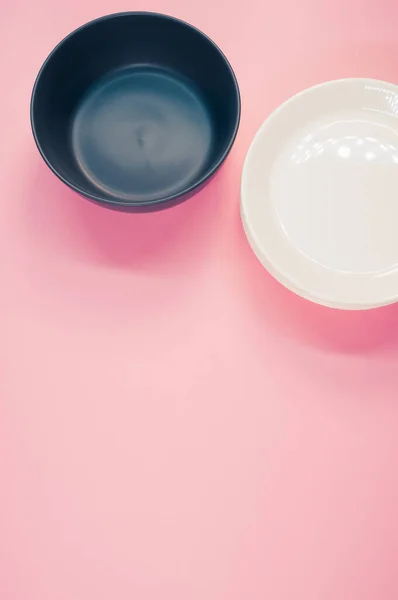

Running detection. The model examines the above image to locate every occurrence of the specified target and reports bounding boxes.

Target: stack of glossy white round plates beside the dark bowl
[241,79,398,309]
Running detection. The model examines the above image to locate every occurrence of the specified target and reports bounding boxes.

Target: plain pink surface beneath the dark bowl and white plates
[0,0,398,600]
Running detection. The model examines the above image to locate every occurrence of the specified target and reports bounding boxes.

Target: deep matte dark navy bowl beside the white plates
[31,12,240,211]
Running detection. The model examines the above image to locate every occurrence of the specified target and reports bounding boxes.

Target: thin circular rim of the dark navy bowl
[30,11,241,208]
